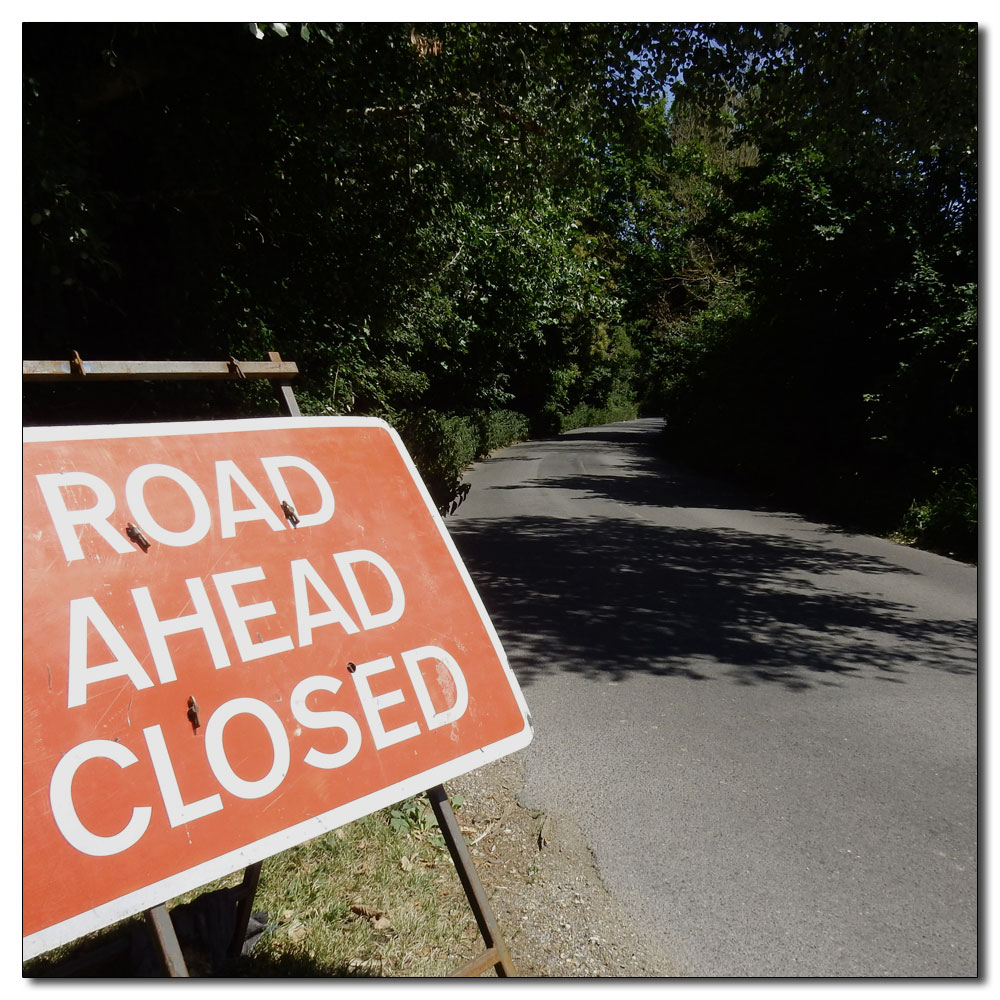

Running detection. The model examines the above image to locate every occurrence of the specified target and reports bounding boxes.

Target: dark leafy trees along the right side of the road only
[643,24,978,551]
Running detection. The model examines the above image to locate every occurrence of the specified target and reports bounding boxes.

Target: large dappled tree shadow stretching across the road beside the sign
[449,512,977,690]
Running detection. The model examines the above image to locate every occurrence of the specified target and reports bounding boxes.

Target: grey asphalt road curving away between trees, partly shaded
[447,420,978,977]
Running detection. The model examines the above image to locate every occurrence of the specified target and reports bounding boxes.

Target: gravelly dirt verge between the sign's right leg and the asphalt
[448,755,678,977]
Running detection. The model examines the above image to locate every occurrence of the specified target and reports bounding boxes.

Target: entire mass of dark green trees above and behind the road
[23,22,978,548]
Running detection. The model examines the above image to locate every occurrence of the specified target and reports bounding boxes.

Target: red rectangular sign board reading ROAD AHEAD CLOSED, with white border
[23,417,531,958]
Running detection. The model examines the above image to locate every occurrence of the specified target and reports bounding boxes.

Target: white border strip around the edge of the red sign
[22,417,532,961]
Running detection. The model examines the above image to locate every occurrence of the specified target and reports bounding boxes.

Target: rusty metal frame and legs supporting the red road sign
[22,351,517,978]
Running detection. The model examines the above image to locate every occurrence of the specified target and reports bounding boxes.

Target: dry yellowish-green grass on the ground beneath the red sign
[23,798,484,977]
